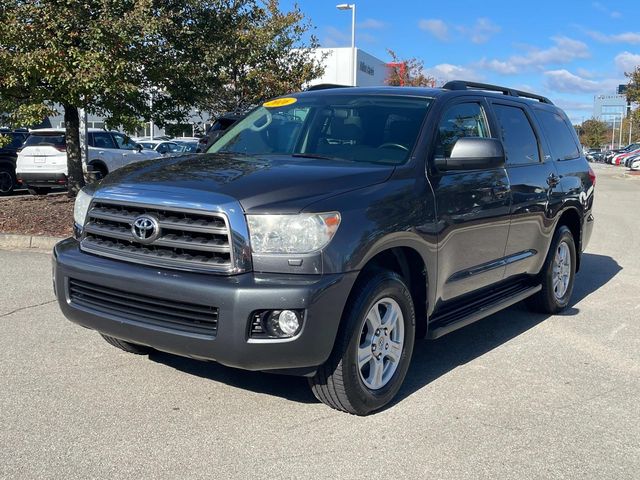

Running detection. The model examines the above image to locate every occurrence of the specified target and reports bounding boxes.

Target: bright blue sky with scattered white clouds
[282,0,640,122]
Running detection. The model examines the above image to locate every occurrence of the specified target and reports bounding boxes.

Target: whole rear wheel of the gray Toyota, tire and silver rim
[527,225,576,314]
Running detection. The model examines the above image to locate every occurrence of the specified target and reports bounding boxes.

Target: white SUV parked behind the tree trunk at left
[16,128,161,194]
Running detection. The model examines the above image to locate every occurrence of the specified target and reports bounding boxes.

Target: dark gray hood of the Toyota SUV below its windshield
[99,154,394,213]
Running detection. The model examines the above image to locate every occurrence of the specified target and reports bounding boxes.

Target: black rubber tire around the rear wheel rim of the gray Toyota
[527,225,576,314]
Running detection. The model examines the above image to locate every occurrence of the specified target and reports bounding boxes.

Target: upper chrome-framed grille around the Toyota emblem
[81,200,232,271]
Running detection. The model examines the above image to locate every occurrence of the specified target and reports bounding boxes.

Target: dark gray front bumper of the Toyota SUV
[53,238,357,374]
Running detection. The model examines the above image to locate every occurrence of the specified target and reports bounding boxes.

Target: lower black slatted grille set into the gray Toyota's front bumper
[69,279,218,337]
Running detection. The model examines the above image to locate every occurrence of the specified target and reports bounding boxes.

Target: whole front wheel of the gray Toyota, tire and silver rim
[309,270,416,415]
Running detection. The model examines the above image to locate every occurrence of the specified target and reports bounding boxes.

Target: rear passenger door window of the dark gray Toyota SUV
[493,104,540,165]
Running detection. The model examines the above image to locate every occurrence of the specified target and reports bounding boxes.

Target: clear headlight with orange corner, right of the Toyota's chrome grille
[247,212,340,253]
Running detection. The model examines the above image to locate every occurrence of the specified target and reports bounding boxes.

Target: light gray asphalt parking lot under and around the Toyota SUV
[0,165,640,479]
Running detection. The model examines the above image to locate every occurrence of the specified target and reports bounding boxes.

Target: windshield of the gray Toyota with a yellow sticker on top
[208,94,431,165]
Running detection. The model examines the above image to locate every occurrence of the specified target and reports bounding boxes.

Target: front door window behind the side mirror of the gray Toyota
[435,103,489,158]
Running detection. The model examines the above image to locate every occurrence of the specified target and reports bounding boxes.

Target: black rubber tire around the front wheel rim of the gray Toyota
[309,270,416,415]
